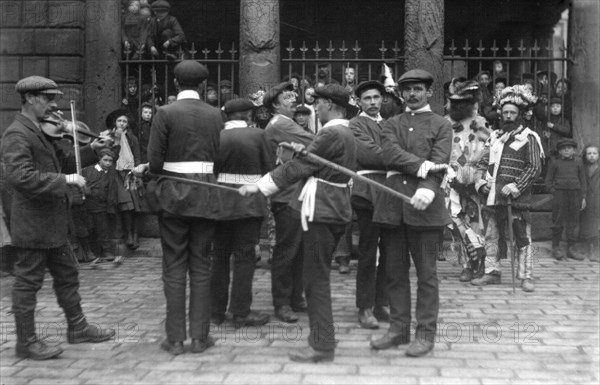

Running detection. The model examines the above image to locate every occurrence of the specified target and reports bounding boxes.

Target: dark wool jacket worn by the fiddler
[0,113,97,249]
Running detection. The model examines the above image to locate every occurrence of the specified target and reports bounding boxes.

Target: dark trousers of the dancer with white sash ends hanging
[302,223,346,350]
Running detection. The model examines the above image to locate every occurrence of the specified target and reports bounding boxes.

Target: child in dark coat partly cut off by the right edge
[579,144,600,262]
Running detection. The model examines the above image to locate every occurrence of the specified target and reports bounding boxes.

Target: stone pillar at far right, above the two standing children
[569,0,600,145]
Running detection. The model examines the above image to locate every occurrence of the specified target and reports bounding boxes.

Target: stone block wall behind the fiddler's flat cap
[0,0,85,133]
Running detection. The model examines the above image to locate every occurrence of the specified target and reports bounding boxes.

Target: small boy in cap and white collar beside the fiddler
[82,149,119,262]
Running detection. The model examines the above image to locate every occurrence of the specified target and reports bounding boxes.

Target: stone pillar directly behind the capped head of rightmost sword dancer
[406,0,444,114]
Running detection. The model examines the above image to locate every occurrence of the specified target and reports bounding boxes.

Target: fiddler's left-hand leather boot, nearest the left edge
[15,312,63,360]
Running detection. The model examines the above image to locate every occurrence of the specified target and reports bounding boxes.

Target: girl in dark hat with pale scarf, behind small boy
[102,110,140,250]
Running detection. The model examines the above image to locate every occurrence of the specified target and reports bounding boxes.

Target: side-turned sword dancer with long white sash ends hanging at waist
[240,84,356,362]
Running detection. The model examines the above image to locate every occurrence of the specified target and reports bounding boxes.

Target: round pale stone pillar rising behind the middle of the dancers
[240,0,281,97]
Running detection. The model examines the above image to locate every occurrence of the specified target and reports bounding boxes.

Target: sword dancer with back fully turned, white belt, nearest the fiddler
[134,60,223,355]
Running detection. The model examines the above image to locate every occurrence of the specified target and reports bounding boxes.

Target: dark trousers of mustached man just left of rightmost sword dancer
[354,208,388,309]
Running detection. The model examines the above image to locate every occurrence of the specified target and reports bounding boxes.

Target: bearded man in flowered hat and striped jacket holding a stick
[471,85,544,292]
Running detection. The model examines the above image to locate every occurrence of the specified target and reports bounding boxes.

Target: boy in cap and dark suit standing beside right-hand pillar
[546,139,587,261]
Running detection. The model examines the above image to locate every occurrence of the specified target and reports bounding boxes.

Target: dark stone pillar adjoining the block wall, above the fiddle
[83,0,122,131]
